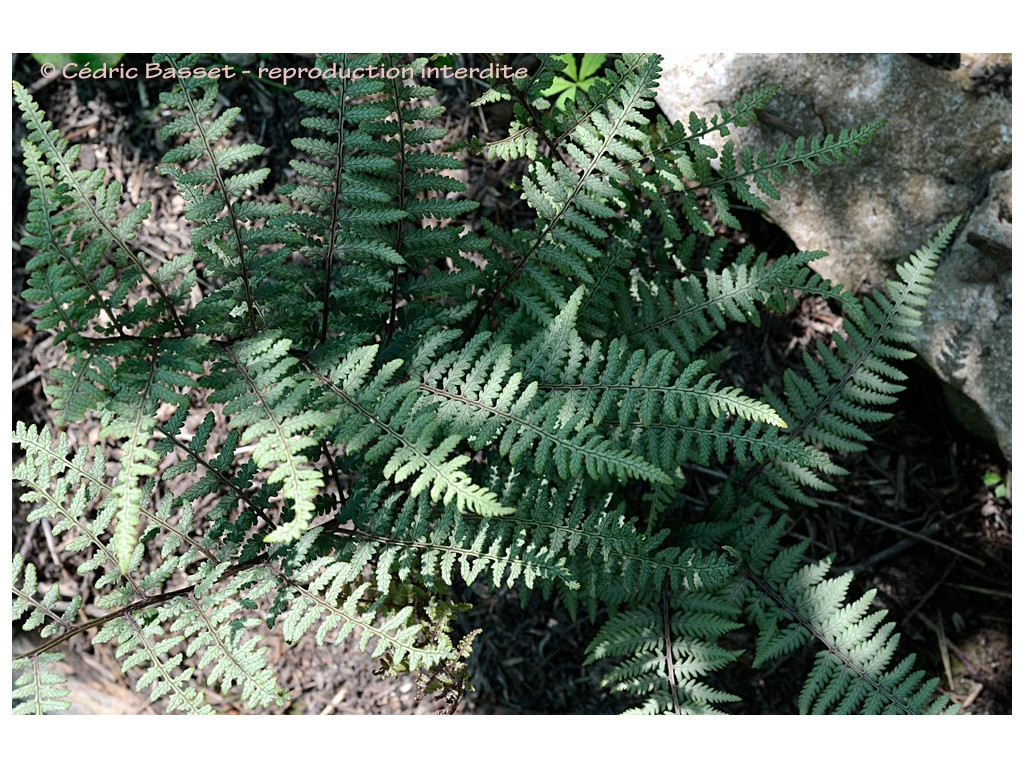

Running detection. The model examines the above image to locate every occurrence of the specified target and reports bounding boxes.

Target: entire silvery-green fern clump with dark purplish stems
[13,54,955,713]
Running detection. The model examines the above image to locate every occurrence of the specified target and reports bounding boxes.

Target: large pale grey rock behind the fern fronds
[657,54,1013,460]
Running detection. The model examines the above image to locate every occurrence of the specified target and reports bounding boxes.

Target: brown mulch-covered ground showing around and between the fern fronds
[12,55,1012,714]
